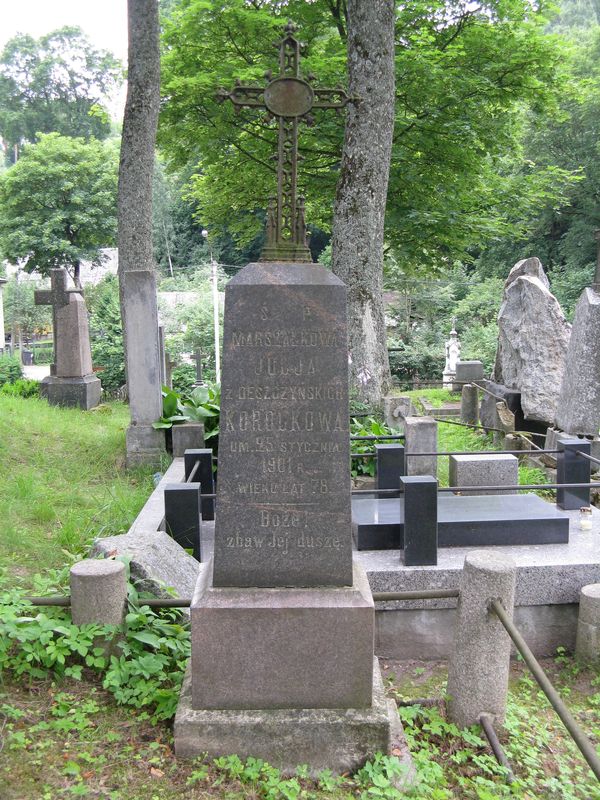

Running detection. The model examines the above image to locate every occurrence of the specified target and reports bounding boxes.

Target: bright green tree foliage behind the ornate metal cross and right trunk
[159,0,568,270]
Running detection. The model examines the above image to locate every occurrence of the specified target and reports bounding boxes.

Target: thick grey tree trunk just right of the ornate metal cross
[332,0,395,405]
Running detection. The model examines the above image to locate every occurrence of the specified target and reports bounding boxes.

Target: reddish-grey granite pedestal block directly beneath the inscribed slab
[191,564,375,710]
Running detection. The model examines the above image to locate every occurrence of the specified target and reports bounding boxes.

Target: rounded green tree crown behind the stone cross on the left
[0,133,117,280]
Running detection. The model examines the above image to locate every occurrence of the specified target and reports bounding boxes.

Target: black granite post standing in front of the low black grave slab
[398,475,438,567]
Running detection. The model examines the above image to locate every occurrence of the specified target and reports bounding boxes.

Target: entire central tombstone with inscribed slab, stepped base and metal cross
[175,27,408,772]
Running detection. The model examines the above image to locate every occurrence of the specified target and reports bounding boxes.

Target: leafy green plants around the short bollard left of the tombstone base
[0,568,190,720]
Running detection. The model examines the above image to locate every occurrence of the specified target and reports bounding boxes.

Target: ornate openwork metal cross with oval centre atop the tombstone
[217,22,355,262]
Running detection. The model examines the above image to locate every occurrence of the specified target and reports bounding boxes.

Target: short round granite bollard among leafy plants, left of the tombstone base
[71,558,127,625]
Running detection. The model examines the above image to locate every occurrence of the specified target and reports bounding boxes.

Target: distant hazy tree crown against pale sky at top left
[0,27,122,161]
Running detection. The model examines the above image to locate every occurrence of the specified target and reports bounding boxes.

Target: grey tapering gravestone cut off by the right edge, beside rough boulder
[556,231,600,440]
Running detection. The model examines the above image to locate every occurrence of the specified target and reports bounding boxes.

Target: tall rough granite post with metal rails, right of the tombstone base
[448,550,516,728]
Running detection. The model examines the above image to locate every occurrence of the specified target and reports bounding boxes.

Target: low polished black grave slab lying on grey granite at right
[352,494,569,550]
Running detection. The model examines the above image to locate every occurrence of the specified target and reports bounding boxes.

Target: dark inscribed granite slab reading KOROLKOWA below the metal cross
[214,262,352,588]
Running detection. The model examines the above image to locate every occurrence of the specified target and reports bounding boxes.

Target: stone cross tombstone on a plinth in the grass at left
[35,267,101,409]
